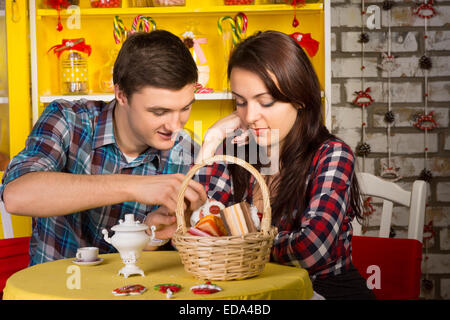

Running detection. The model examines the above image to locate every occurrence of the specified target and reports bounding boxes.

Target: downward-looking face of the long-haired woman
[230,68,297,147]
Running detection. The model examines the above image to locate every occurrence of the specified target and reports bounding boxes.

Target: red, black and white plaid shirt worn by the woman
[196,139,355,279]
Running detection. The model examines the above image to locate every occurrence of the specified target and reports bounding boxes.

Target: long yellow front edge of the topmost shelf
[36,3,323,17]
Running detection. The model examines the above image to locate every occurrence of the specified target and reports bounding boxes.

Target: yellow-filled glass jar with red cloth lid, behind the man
[49,38,91,95]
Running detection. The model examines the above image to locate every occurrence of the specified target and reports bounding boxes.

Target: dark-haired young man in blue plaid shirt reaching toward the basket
[0,30,206,265]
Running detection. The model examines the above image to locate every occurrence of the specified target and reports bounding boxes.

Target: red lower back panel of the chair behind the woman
[352,236,422,300]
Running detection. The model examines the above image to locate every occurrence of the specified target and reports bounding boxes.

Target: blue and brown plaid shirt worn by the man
[0,100,199,265]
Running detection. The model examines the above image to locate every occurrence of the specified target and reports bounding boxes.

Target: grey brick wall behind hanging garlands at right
[331,0,450,299]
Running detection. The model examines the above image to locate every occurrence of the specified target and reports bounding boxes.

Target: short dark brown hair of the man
[113,30,198,98]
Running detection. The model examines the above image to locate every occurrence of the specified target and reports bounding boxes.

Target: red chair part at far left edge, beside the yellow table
[0,237,30,299]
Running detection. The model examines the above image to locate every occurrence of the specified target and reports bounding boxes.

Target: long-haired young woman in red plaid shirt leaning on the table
[198,31,374,299]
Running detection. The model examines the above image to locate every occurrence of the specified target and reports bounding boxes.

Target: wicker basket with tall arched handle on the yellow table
[173,155,277,280]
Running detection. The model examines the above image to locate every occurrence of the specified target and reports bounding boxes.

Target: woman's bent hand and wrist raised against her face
[195,111,248,163]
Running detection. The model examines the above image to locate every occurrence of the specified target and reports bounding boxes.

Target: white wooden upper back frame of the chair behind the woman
[352,172,427,242]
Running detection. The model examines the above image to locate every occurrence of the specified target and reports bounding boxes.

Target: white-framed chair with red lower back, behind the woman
[352,173,427,300]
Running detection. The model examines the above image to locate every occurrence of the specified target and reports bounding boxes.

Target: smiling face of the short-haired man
[116,84,195,152]
